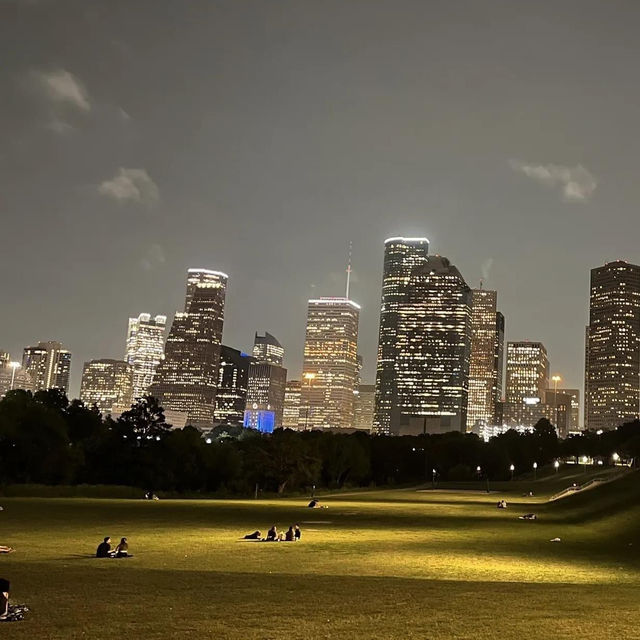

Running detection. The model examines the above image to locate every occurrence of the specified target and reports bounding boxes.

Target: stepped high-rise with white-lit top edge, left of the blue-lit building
[150,269,228,428]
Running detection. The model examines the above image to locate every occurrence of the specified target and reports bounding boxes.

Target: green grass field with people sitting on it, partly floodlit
[0,469,640,640]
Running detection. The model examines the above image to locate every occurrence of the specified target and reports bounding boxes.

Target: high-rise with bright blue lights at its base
[244,332,287,432]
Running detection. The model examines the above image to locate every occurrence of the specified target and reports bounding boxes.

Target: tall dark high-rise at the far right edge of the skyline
[585,260,640,431]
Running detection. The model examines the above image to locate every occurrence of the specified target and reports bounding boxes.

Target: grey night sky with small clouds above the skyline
[0,0,640,395]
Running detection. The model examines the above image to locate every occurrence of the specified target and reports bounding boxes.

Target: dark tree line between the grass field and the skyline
[0,389,640,495]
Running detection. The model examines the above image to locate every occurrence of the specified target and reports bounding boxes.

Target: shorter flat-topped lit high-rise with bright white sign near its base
[503,341,553,426]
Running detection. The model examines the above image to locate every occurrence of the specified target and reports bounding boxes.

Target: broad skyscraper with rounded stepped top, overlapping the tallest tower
[390,256,471,433]
